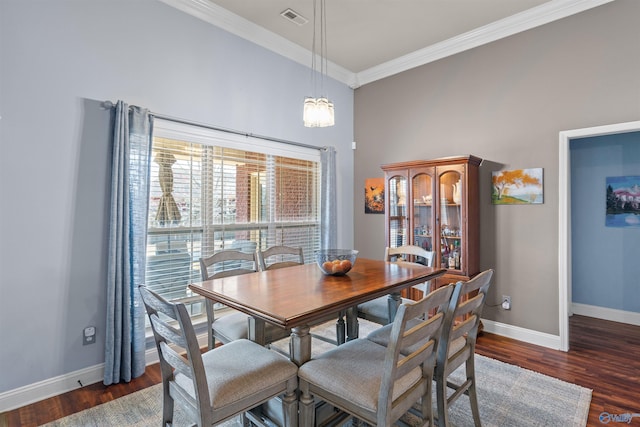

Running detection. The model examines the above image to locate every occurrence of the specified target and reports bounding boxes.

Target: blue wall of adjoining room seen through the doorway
[570,132,640,313]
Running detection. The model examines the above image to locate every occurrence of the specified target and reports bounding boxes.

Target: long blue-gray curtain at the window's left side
[104,101,153,385]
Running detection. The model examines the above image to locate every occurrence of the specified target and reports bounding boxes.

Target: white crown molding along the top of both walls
[160,0,614,89]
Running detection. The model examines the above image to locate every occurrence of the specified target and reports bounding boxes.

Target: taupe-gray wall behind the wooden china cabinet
[354,0,640,335]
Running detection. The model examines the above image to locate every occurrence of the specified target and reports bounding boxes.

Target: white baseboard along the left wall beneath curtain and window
[0,333,207,412]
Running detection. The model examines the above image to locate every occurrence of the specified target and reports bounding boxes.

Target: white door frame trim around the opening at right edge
[558,121,640,351]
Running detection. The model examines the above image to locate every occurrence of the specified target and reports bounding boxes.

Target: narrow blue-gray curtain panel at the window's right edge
[320,147,338,249]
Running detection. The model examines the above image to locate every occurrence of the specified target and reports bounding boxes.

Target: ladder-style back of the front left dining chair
[139,285,211,419]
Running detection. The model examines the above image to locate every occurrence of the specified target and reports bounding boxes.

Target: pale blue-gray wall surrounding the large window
[0,0,353,393]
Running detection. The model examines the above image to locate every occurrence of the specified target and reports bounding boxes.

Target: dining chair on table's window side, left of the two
[200,250,290,350]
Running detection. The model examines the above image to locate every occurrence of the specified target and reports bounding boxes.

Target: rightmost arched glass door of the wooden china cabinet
[440,171,464,270]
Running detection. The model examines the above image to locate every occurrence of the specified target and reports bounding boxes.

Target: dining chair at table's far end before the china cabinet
[358,245,434,325]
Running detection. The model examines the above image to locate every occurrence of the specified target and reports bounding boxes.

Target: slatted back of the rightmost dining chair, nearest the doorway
[437,270,493,378]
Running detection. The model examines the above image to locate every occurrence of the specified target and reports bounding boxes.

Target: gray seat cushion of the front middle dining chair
[298,339,422,412]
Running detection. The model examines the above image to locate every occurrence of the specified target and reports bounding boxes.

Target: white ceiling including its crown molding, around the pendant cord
[162,0,612,88]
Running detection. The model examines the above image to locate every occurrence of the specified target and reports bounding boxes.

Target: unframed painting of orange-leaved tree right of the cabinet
[491,168,544,205]
